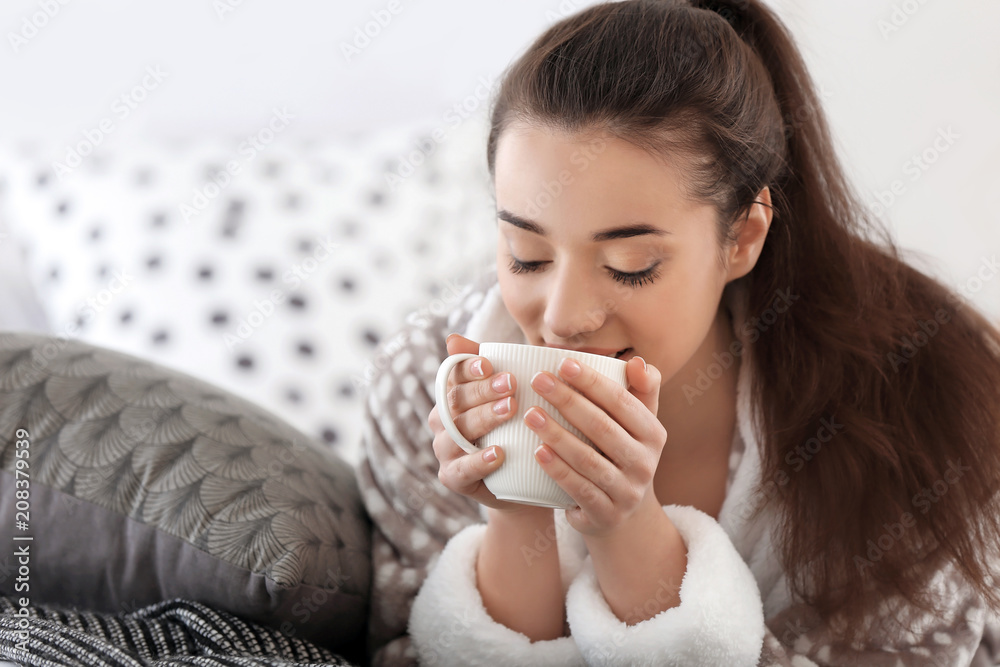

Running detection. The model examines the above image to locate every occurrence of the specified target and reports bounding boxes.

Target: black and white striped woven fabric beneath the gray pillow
[0,597,351,667]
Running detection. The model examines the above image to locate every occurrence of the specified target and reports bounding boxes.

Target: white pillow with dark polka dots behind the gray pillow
[0,119,496,462]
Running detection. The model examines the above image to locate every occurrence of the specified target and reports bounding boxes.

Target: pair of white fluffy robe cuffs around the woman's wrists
[409,505,764,667]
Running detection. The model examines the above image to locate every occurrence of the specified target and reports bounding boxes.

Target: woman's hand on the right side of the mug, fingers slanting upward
[524,357,667,535]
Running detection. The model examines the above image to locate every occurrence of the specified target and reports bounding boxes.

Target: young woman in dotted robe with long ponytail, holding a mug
[360,0,1000,667]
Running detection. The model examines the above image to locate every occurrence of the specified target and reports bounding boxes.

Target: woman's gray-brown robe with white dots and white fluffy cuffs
[358,270,1000,667]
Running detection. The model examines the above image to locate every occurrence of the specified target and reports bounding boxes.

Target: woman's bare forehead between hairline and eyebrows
[494,123,702,226]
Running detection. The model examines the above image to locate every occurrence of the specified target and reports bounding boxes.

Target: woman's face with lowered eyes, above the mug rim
[494,124,730,382]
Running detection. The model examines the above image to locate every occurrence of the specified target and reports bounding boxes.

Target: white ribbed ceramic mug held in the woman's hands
[435,343,627,509]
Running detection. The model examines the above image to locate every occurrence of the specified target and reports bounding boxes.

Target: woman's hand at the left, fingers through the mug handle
[427,334,551,514]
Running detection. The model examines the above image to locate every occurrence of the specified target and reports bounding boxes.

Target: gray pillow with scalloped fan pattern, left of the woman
[0,332,371,649]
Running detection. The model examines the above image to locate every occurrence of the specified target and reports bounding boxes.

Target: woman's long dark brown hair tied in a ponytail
[487,0,1000,639]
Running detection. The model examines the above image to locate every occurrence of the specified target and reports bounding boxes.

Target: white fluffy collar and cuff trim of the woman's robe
[409,280,776,667]
